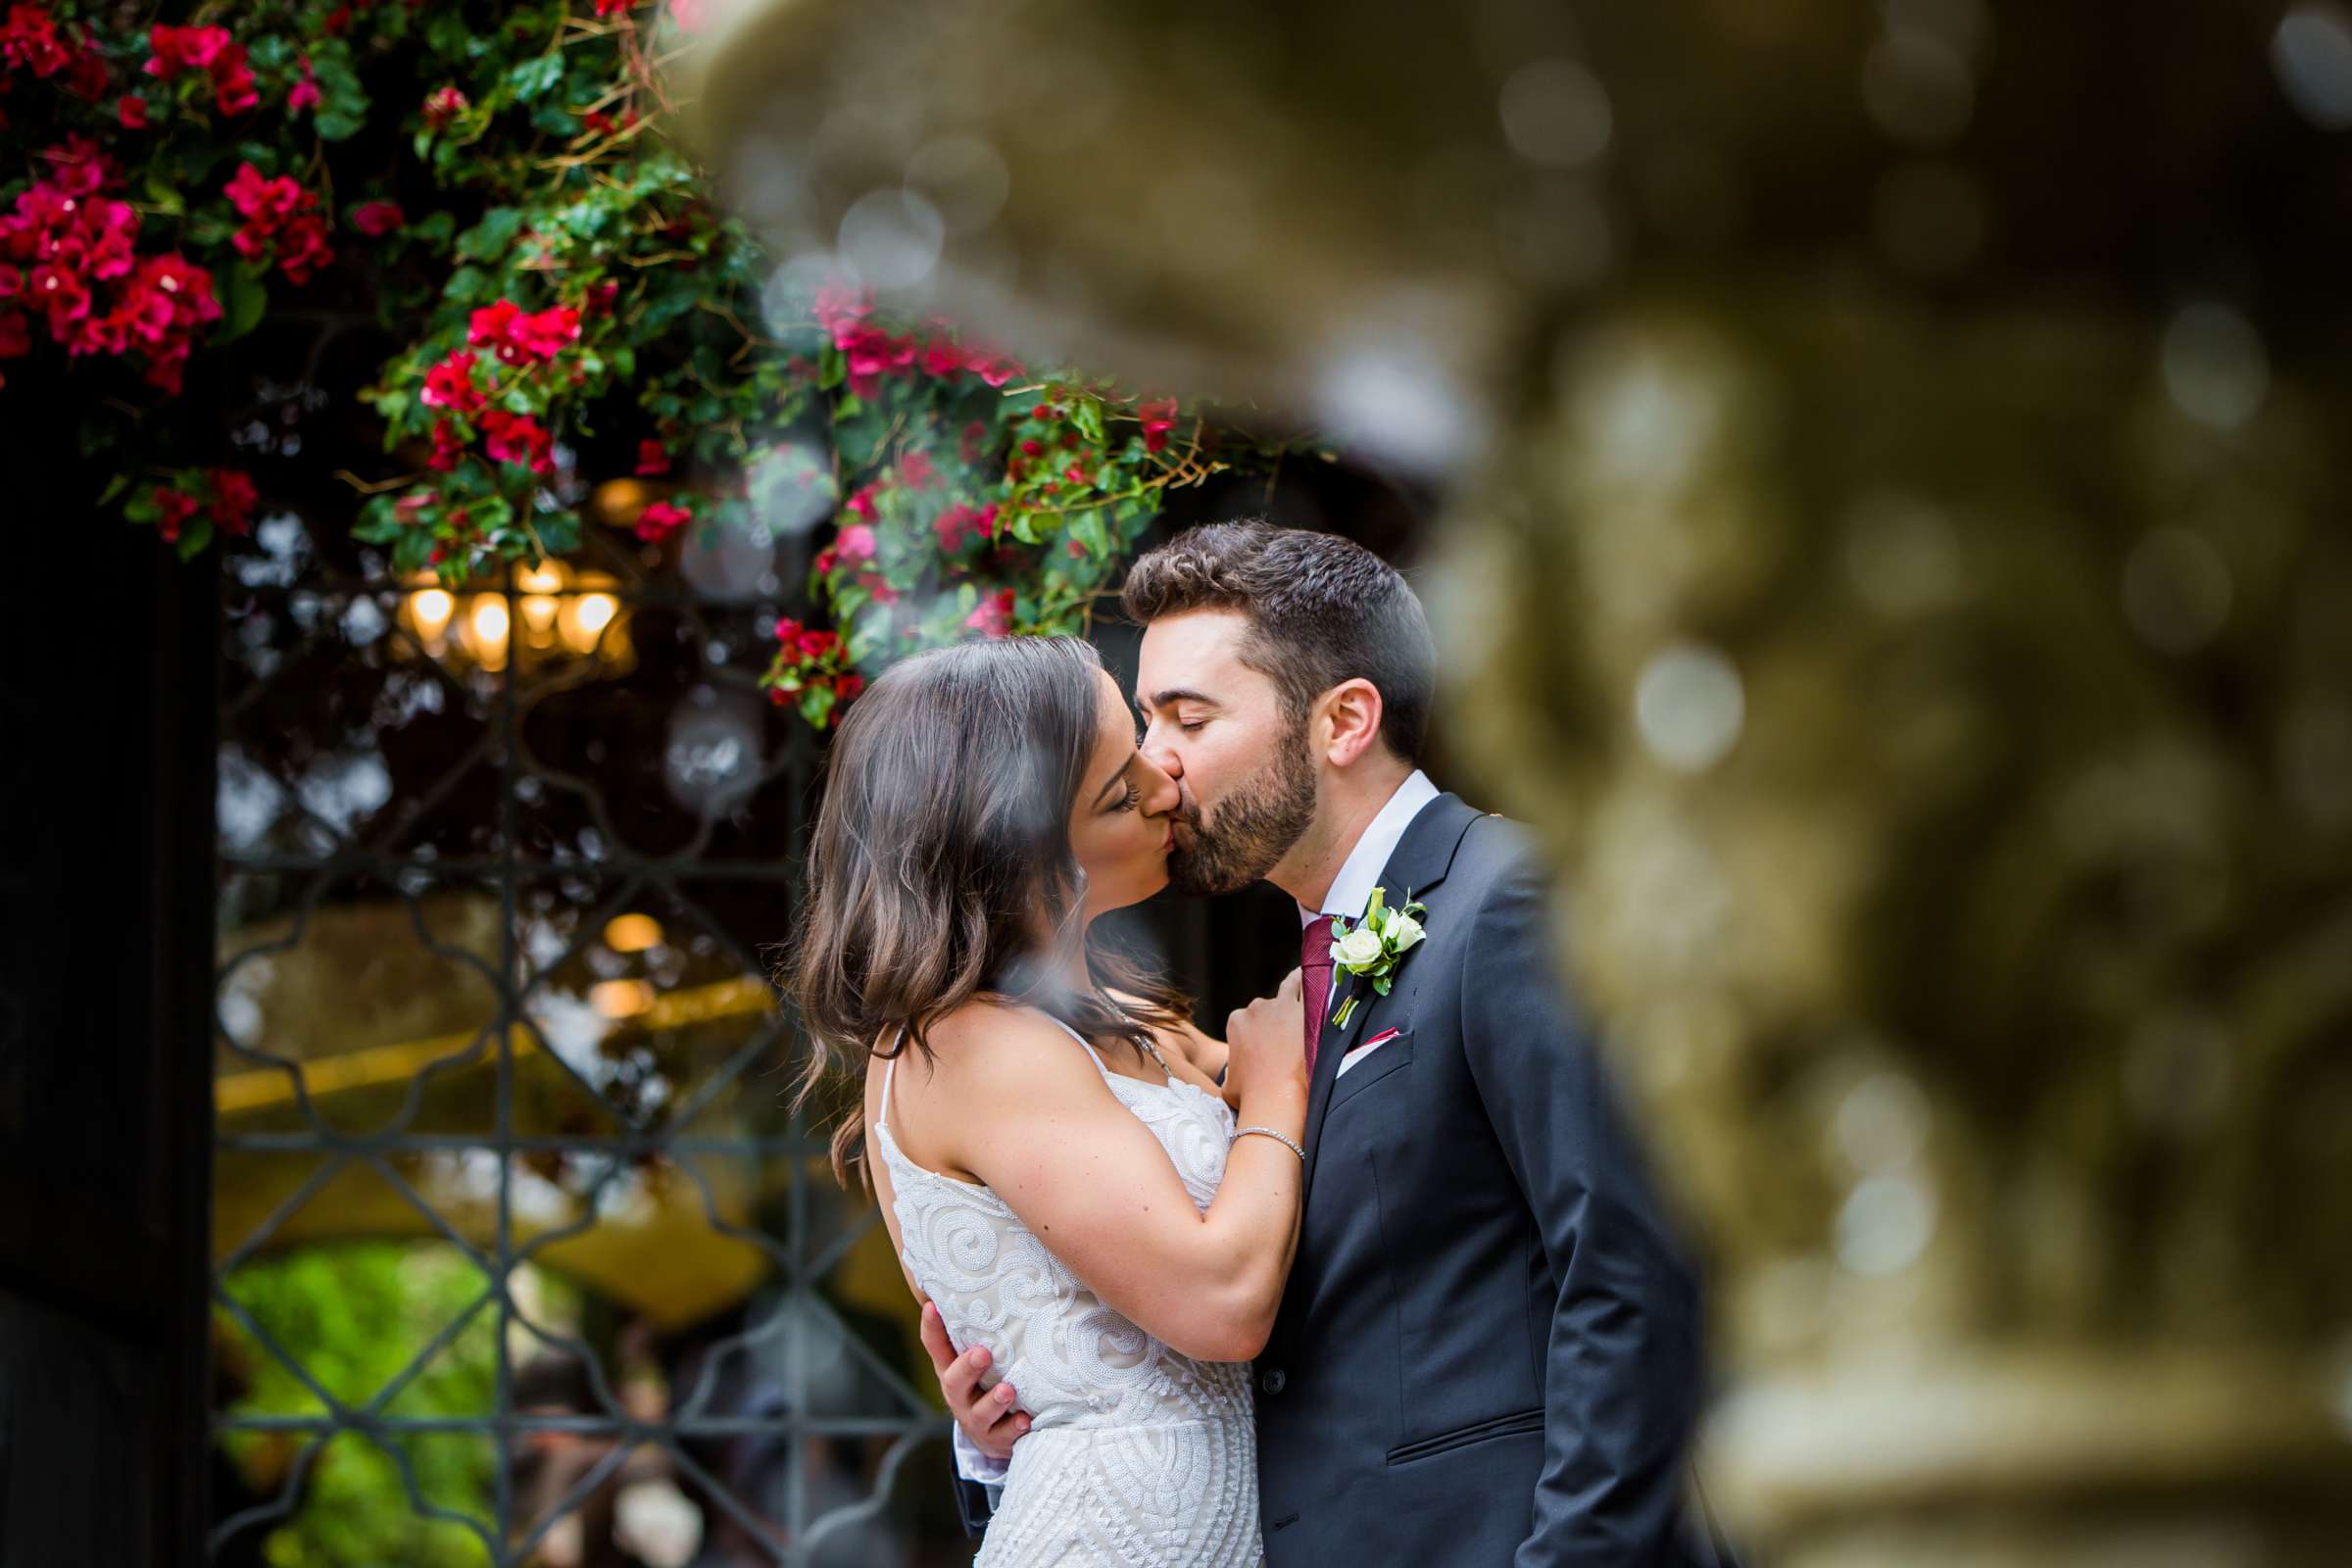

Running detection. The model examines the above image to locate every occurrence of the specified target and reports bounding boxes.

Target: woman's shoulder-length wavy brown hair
[786,637,1193,1185]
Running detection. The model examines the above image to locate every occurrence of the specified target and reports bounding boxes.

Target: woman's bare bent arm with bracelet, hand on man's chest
[939,995,1305,1361]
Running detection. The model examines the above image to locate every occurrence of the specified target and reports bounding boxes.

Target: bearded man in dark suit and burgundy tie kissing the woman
[924,522,1700,1568]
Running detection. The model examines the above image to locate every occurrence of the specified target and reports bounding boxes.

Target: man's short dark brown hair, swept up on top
[1119,517,1437,761]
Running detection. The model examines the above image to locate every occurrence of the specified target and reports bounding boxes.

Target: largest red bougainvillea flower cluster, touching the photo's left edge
[0,137,221,393]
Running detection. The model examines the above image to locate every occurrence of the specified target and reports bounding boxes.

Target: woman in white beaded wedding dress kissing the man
[793,637,1307,1568]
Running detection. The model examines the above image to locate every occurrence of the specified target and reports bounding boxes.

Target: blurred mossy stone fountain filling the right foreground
[689,0,2352,1568]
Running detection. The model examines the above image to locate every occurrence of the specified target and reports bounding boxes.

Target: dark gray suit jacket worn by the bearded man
[1256,795,1703,1568]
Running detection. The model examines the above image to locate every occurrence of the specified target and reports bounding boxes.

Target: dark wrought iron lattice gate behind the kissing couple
[212,517,969,1566]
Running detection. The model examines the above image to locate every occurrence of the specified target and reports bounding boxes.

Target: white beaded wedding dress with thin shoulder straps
[872,1032,1263,1568]
